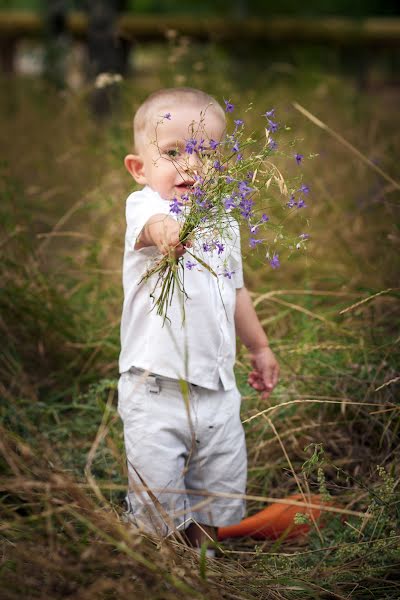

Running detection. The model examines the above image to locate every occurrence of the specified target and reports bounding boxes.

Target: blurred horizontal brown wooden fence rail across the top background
[0,11,400,46]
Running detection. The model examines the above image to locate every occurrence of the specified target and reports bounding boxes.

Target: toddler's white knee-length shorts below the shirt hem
[118,368,247,536]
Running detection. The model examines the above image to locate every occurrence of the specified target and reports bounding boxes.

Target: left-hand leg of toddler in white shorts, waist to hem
[118,373,191,536]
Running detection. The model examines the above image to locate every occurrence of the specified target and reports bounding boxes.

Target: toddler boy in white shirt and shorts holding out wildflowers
[118,88,279,546]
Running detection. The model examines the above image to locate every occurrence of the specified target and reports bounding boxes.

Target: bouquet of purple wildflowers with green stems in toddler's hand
[141,100,310,319]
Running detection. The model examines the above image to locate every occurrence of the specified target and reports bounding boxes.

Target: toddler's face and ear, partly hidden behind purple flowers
[125,105,225,200]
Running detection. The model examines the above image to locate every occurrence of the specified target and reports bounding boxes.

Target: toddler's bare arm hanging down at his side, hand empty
[235,287,279,399]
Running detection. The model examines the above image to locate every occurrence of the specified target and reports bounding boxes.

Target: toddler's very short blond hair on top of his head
[133,87,225,150]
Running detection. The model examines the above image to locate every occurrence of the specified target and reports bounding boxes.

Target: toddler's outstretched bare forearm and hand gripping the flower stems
[135,214,185,258]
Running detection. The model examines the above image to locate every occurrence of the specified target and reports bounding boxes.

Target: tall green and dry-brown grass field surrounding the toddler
[0,40,400,600]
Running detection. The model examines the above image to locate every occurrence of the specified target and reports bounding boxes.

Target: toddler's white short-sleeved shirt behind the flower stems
[119,186,243,390]
